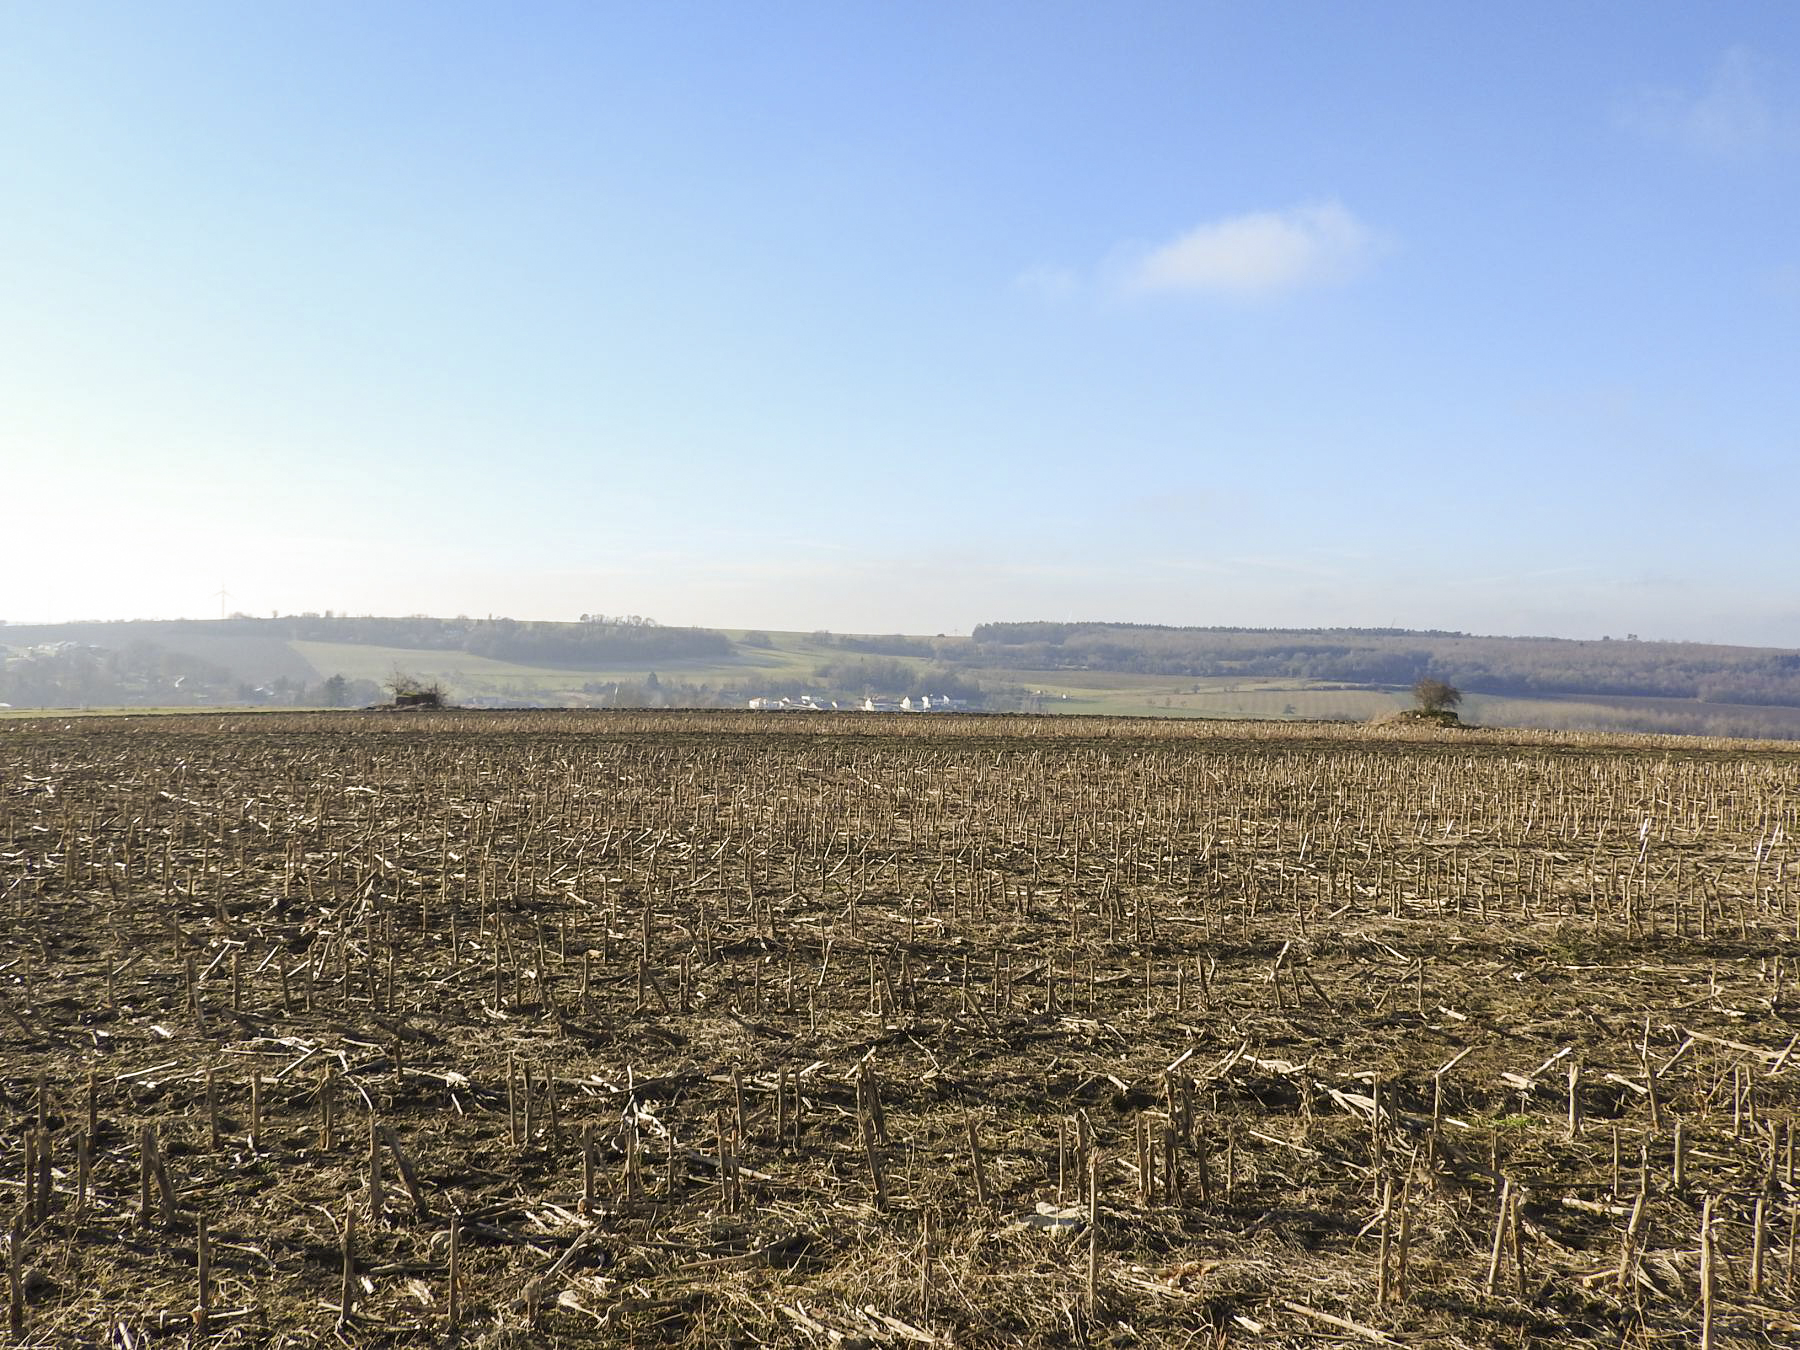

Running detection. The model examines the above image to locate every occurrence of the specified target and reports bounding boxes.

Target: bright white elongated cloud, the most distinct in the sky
[1120,202,1377,299]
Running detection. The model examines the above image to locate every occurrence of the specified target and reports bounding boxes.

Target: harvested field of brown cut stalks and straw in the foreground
[0,713,1800,1346]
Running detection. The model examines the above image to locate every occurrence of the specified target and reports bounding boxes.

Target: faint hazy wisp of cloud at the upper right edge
[1615,47,1800,160]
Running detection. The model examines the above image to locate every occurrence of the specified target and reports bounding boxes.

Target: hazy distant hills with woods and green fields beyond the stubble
[10,616,1800,738]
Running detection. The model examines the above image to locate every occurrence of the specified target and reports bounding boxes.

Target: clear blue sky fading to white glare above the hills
[0,0,1800,646]
